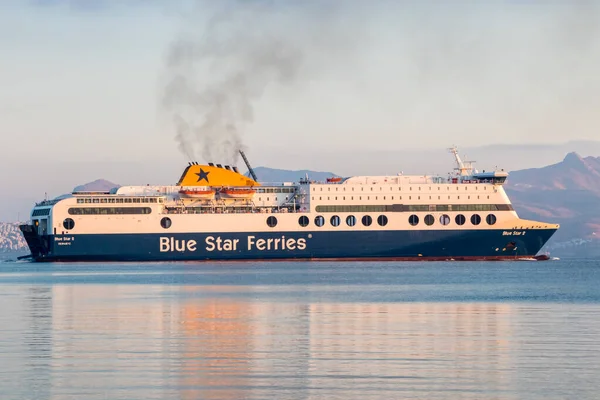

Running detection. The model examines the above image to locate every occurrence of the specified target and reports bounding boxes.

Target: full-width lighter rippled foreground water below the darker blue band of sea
[0,285,600,400]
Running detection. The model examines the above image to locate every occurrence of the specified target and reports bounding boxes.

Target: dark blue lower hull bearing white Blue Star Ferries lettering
[37,229,555,261]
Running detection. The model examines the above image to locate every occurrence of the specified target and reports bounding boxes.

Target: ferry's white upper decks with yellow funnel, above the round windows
[34,148,512,219]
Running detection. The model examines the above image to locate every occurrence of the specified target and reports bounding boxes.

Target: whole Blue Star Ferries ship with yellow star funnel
[20,147,559,261]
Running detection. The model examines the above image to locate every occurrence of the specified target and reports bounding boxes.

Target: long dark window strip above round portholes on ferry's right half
[315,204,513,212]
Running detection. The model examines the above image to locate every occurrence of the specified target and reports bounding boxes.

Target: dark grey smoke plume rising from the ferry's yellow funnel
[162,1,303,164]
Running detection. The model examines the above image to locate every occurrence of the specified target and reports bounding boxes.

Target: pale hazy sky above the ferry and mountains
[0,0,600,220]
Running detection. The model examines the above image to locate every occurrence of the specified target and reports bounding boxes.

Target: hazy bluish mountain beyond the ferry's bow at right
[506,153,600,253]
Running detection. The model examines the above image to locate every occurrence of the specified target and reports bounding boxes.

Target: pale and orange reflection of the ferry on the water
[39,286,516,399]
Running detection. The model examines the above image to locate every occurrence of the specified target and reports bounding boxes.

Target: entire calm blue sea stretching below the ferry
[0,260,600,400]
